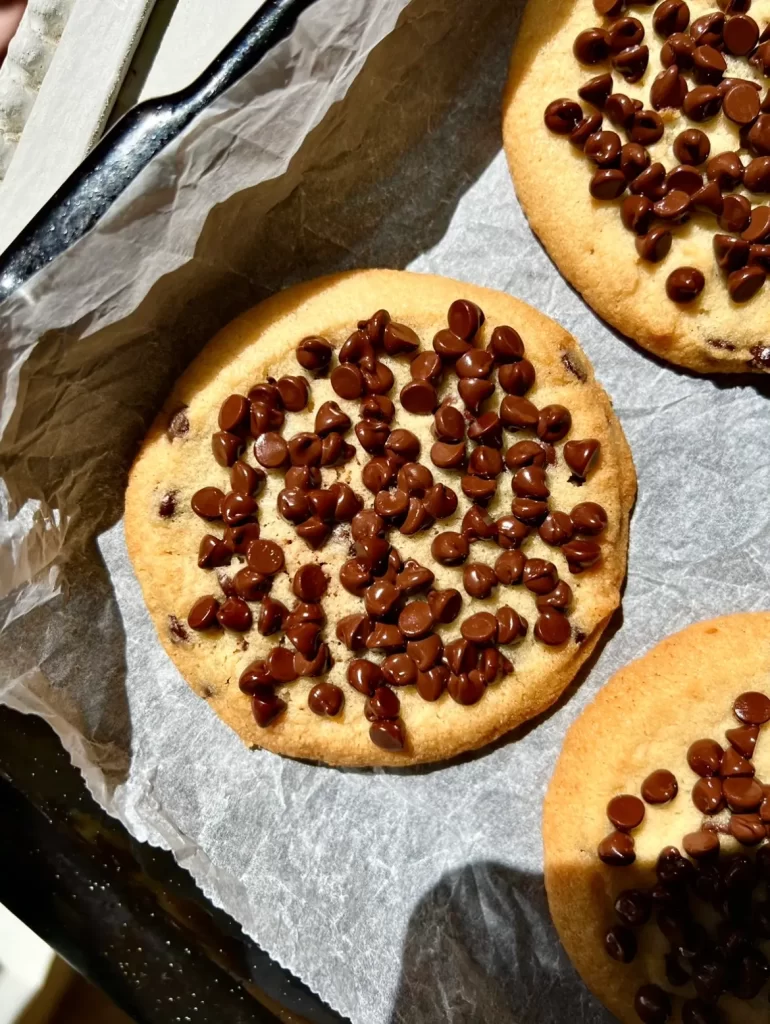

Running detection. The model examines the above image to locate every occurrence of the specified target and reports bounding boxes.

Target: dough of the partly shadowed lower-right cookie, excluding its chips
[543,612,770,1024]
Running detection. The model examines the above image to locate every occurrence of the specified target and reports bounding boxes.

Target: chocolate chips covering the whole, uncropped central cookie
[170,300,607,751]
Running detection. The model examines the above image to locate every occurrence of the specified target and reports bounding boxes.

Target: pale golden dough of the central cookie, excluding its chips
[125,270,636,765]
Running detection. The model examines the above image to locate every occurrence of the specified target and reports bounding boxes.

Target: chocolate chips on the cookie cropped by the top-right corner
[545,0,770,303]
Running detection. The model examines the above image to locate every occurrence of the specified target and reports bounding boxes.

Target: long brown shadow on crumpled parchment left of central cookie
[0,0,536,784]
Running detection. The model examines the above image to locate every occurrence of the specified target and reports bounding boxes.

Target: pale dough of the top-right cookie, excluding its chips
[504,0,770,373]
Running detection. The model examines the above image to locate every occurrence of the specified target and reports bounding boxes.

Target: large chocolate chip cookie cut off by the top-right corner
[504,0,770,372]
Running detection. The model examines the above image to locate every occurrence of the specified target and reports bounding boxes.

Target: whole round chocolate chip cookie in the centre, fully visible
[126,270,635,765]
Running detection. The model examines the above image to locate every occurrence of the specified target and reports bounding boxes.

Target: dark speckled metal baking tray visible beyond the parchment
[0,0,344,1024]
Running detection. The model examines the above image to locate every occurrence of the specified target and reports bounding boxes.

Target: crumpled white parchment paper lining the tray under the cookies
[0,0,770,1024]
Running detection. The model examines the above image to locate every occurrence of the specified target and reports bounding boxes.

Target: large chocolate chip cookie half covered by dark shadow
[543,612,770,1024]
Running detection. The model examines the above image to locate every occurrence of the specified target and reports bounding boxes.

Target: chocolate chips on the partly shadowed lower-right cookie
[598,692,770,1024]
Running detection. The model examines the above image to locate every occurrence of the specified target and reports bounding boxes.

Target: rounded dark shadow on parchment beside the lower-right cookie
[389,864,614,1024]
